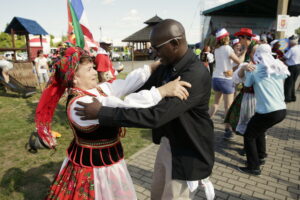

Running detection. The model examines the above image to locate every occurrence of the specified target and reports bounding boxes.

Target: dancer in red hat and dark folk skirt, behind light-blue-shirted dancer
[224,28,257,139]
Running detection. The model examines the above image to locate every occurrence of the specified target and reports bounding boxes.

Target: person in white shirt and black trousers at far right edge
[284,35,300,103]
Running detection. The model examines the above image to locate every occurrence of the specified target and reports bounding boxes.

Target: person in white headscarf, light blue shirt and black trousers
[239,44,290,175]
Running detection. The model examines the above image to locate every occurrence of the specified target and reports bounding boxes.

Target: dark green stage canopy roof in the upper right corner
[203,0,300,18]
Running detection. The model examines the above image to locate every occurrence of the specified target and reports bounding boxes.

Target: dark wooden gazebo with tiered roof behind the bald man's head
[122,15,162,60]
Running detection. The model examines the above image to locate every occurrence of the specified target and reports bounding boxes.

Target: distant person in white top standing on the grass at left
[34,50,49,88]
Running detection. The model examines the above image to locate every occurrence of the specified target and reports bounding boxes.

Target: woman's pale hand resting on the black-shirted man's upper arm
[158,76,192,100]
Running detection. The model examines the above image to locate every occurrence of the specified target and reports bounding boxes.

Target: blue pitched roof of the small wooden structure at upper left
[4,17,48,35]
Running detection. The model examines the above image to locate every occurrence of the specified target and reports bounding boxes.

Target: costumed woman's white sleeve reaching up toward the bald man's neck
[99,65,151,97]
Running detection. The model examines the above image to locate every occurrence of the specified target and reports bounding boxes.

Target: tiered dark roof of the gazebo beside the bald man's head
[122,15,162,42]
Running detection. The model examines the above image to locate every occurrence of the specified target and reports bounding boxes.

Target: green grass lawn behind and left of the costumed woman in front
[0,73,213,200]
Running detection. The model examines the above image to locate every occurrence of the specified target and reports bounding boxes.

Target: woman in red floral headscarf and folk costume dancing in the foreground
[35,47,189,200]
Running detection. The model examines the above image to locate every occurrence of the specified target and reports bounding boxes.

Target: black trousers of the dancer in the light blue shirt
[244,109,286,170]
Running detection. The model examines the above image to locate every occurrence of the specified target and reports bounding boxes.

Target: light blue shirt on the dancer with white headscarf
[245,64,287,114]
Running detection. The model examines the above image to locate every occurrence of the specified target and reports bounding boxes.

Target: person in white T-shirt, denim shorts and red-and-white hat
[209,28,240,138]
